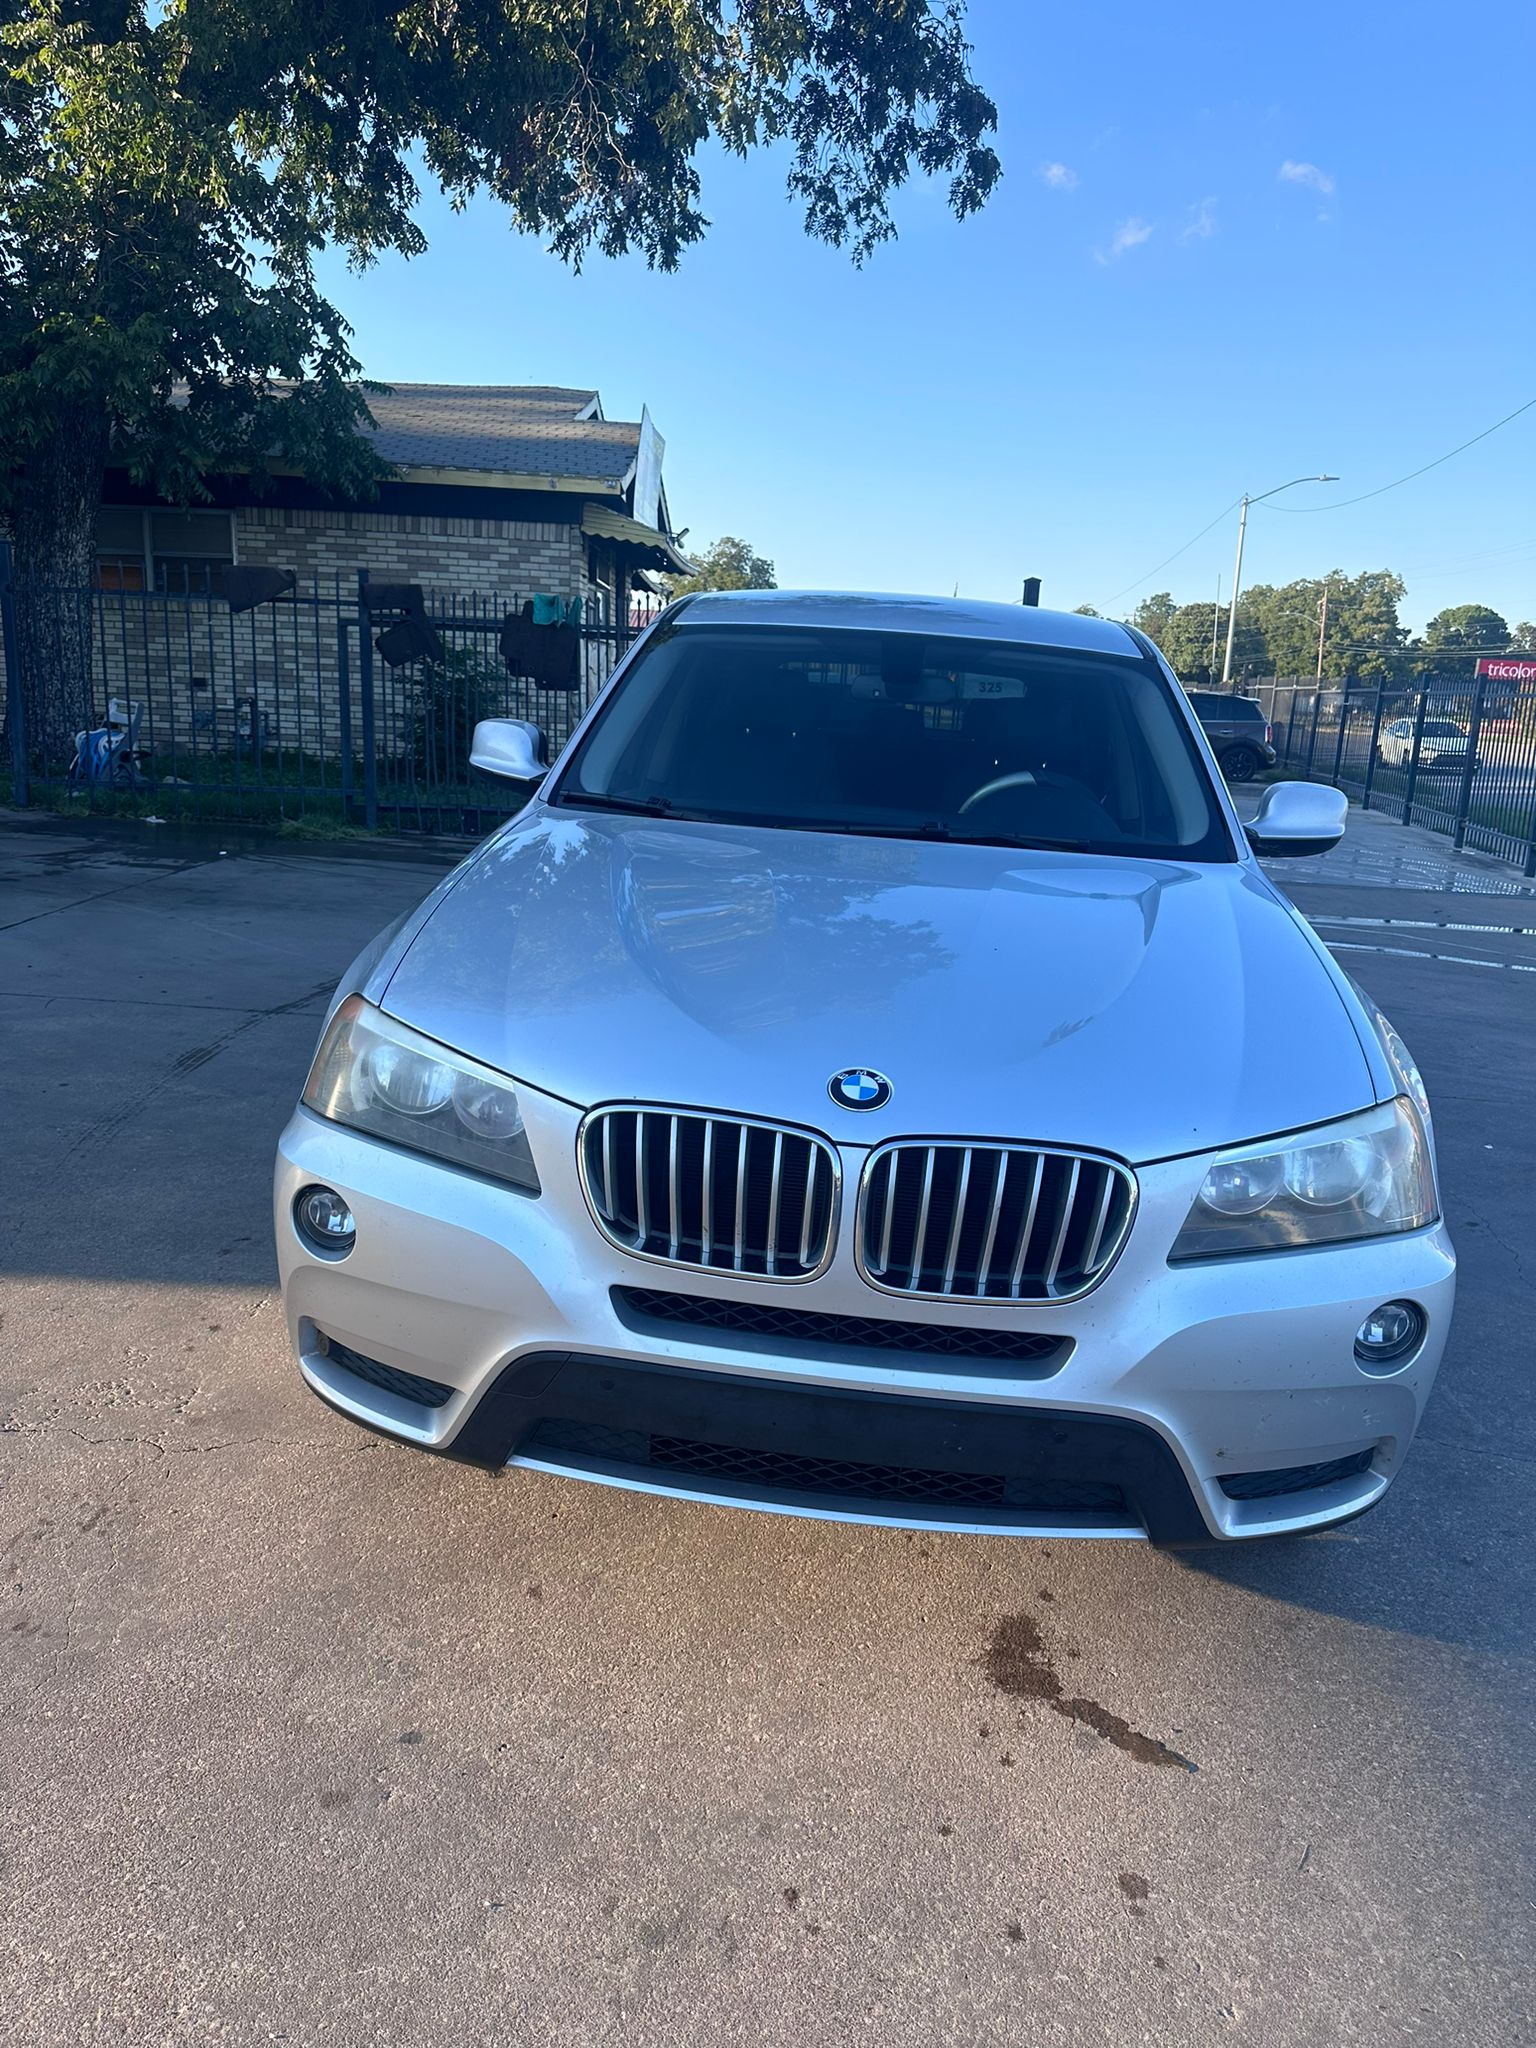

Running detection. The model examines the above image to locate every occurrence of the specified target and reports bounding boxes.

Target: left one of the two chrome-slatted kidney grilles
[580,1108,838,1280]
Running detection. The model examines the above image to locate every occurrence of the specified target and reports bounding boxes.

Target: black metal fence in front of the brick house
[0,555,635,834]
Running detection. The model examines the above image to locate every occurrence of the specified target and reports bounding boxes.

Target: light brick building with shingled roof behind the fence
[61,385,690,780]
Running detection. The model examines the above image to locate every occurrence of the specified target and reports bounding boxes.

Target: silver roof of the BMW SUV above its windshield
[678,590,1141,662]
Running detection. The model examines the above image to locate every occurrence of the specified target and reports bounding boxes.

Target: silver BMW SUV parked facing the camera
[276,592,1454,1544]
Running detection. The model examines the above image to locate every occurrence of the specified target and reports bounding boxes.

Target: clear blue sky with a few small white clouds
[315,0,1536,629]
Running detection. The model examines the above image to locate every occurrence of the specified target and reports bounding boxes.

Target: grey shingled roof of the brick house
[369,385,641,483]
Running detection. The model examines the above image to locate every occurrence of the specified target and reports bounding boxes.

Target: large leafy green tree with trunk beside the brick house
[0,0,999,752]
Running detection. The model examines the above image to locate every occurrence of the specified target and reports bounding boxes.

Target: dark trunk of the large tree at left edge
[10,406,106,774]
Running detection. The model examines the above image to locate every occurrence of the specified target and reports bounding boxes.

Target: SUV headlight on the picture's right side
[1169,1096,1438,1260]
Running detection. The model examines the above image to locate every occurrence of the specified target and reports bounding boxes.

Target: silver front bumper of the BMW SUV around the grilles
[274,1087,1454,1542]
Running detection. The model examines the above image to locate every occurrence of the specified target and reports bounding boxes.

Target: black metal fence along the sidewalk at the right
[1243,676,1536,874]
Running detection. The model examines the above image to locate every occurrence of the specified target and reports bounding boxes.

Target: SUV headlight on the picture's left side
[303,995,539,1194]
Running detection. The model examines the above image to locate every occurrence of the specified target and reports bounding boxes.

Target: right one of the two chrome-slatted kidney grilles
[858,1145,1137,1300]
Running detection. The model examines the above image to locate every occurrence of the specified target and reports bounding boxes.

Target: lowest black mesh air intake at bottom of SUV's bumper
[518,1421,1124,1513]
